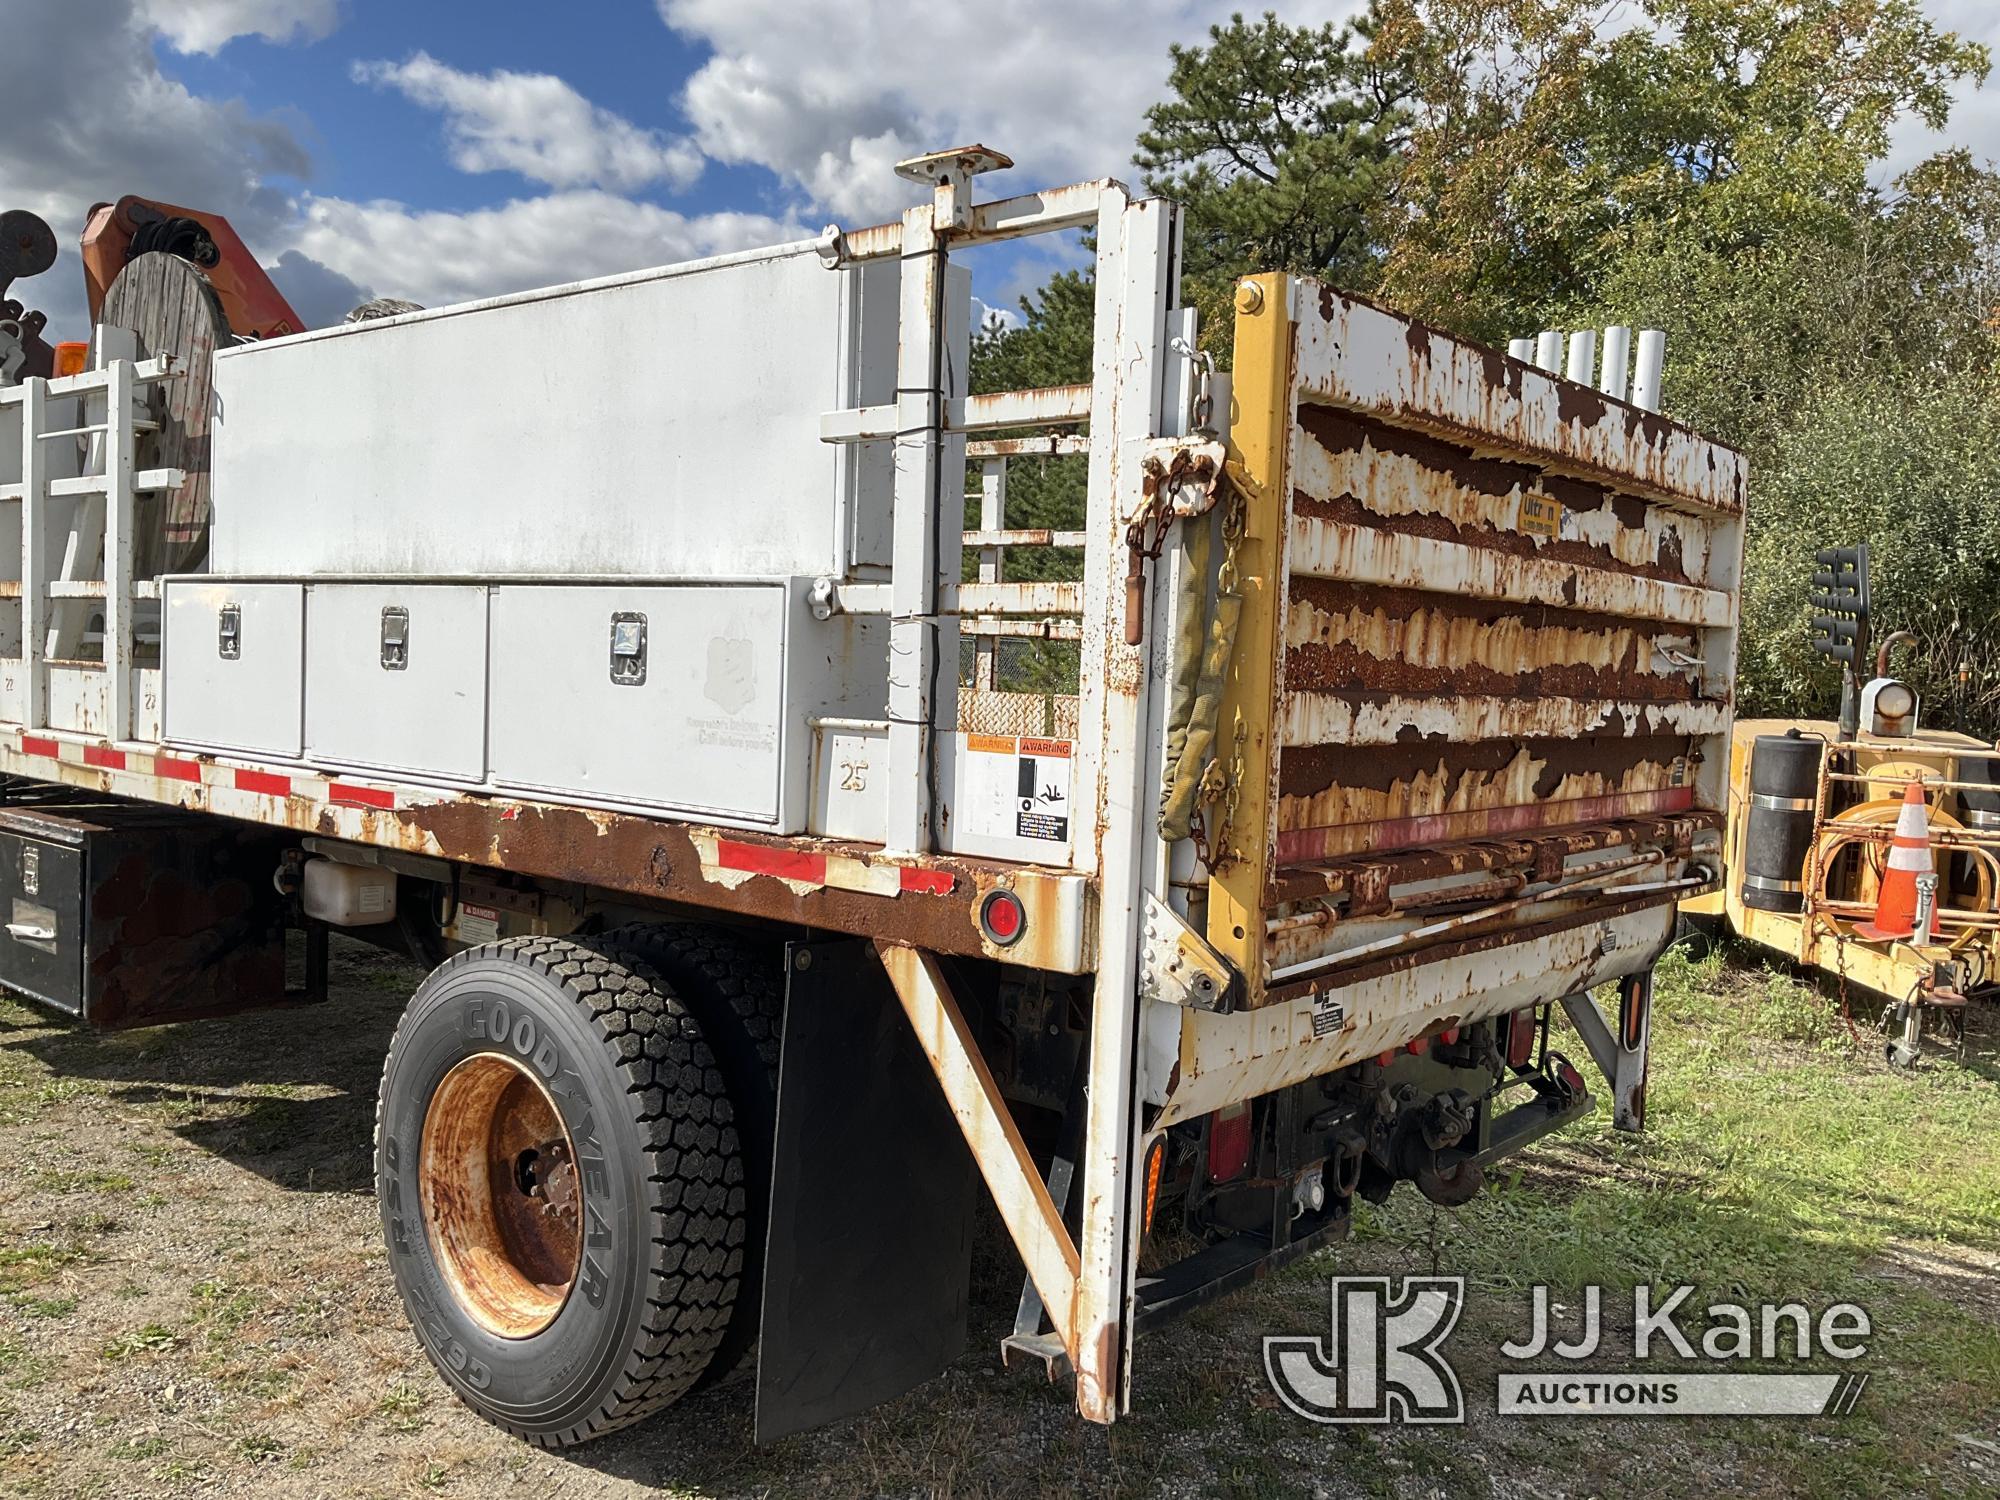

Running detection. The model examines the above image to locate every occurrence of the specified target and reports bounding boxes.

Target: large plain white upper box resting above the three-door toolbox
[210,244,908,580]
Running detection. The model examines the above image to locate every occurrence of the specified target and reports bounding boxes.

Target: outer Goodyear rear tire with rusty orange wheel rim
[376,938,746,1448]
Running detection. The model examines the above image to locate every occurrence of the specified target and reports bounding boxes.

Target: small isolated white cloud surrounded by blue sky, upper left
[354,52,702,192]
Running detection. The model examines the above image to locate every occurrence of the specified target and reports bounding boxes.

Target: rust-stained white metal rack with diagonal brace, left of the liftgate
[820,146,1180,1422]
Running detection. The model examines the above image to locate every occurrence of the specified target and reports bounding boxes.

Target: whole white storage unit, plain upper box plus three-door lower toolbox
[162,242,970,836]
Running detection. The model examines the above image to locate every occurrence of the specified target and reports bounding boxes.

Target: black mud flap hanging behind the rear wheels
[756,942,978,1442]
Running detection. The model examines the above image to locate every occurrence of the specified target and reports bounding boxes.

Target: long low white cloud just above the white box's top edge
[288,190,808,308]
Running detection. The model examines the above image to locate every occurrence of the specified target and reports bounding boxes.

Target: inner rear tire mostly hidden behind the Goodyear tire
[608,922,784,1384]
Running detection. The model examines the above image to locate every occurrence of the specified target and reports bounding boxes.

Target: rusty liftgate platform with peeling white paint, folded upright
[1252,282,1742,1000]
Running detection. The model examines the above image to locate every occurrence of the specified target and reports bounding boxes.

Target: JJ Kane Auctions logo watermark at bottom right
[1264,1276,1872,1422]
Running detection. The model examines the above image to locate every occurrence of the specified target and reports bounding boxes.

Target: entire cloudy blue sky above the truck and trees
[0,0,2000,334]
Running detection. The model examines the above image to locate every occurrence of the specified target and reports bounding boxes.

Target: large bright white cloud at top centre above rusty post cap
[656,0,1360,222]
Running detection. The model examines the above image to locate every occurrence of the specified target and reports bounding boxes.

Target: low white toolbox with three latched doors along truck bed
[164,578,888,832]
